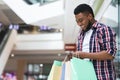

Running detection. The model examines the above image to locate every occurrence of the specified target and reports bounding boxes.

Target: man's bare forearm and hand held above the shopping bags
[76,51,114,60]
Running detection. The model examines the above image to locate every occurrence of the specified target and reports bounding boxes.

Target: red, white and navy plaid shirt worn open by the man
[77,22,117,80]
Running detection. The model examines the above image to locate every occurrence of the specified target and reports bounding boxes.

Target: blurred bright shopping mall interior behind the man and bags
[0,0,120,80]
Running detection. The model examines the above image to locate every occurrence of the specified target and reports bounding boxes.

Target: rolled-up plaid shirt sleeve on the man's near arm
[99,27,117,56]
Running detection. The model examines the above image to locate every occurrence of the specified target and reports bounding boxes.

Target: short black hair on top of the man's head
[74,4,94,17]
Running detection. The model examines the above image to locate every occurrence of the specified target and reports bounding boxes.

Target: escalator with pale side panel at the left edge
[0,29,17,75]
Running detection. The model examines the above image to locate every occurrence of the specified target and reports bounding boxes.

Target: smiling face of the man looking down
[75,13,91,30]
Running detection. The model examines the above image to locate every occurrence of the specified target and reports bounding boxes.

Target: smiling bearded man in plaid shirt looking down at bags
[73,4,117,80]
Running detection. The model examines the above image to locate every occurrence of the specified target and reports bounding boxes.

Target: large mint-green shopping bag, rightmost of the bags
[70,57,97,80]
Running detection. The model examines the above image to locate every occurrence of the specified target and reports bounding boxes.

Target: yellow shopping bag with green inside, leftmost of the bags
[47,60,62,80]
